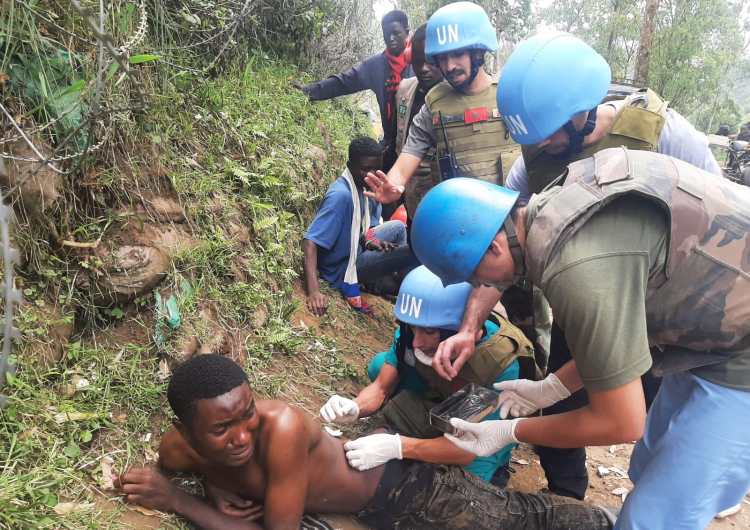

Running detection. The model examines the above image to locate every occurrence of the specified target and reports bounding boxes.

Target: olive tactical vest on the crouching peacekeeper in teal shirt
[415,315,541,400]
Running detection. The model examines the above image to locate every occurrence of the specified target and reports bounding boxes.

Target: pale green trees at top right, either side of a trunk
[539,0,750,132]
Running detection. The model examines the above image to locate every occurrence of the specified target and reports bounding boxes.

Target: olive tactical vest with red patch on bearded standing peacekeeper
[425,81,520,184]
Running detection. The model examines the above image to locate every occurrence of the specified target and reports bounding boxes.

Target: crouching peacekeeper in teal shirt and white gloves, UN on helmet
[320,267,536,484]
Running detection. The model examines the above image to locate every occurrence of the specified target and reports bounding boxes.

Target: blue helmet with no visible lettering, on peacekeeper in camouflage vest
[411,178,522,285]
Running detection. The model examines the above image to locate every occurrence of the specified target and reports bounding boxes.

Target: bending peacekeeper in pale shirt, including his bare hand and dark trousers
[436,32,721,499]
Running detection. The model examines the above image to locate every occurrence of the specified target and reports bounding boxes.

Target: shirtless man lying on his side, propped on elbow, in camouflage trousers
[116,355,613,530]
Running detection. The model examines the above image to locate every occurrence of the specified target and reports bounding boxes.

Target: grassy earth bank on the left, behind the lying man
[0,0,390,530]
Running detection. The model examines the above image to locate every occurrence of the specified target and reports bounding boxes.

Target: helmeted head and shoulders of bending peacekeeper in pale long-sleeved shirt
[497,32,721,203]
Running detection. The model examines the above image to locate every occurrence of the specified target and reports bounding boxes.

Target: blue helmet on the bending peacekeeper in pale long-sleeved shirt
[497,32,612,146]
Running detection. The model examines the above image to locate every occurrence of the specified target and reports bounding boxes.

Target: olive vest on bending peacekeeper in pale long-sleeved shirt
[522,88,668,193]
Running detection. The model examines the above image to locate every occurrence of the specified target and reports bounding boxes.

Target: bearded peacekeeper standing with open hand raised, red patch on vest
[366,2,520,210]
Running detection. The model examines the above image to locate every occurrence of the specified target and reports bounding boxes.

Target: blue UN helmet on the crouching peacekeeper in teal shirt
[393,266,471,331]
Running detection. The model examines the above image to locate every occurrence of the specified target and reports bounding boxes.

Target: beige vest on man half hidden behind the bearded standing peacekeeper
[396,77,440,219]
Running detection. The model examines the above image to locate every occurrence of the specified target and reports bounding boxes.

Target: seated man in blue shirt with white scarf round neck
[302,137,417,315]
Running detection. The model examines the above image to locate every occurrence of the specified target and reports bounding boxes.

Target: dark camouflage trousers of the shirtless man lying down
[359,460,612,530]
